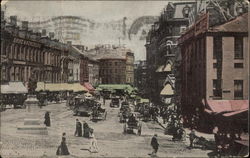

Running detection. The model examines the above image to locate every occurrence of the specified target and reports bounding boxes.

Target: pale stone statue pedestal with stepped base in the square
[17,95,48,135]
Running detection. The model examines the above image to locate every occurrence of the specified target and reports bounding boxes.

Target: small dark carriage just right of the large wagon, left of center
[90,103,107,121]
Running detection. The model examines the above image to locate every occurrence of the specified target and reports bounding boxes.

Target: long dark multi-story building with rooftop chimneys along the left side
[1,12,68,83]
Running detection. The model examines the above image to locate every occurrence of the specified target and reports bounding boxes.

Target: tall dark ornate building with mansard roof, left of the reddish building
[145,2,195,103]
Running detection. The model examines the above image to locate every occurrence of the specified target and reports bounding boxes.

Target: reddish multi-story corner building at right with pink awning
[179,13,249,131]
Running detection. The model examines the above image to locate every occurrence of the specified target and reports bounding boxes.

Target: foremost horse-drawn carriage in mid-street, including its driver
[123,113,142,135]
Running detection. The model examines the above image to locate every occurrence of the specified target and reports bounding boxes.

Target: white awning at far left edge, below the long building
[1,82,28,94]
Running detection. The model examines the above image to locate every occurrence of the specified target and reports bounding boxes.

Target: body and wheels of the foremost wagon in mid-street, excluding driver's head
[123,113,142,136]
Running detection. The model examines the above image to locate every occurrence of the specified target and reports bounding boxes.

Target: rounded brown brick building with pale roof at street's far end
[84,45,134,85]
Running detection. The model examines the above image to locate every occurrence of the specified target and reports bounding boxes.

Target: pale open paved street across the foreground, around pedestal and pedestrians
[1,101,213,157]
